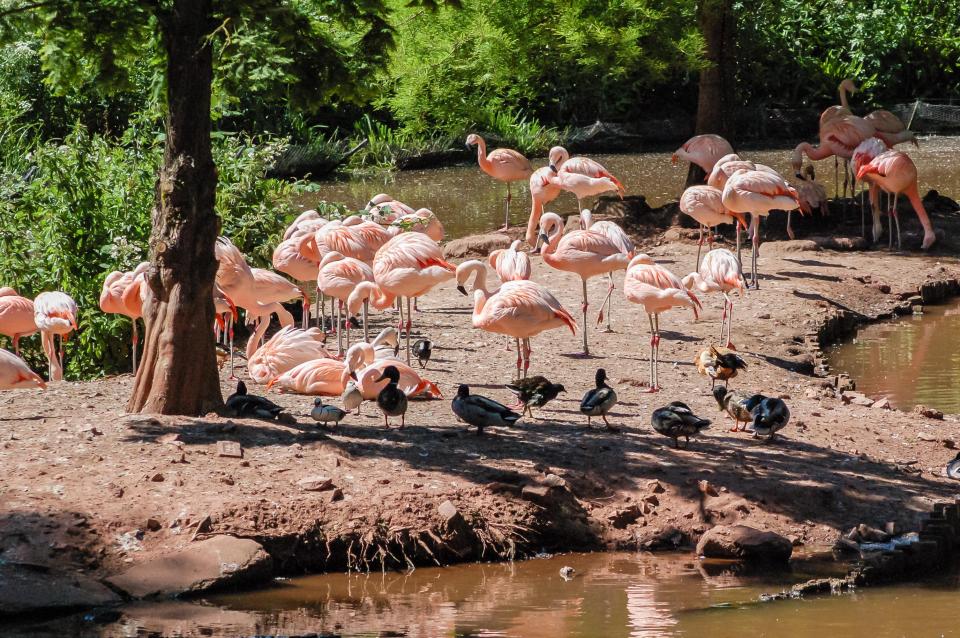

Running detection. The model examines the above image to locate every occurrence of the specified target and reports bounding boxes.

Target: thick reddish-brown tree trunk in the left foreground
[127,0,223,415]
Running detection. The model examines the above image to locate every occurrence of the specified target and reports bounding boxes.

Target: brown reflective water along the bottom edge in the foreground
[13,553,960,638]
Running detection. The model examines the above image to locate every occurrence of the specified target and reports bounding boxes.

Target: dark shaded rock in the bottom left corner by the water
[0,561,121,618]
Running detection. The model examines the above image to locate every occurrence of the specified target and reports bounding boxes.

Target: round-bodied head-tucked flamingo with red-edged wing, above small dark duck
[373,233,456,364]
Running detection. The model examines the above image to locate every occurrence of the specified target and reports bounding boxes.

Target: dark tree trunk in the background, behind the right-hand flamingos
[687,0,736,186]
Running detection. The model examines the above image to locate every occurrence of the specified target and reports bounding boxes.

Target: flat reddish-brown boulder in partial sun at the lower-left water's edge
[107,536,273,598]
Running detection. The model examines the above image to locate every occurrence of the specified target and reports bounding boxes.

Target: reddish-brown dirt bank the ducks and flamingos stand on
[0,202,960,612]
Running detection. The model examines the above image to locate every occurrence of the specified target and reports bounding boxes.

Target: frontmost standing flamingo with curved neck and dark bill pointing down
[457,262,577,378]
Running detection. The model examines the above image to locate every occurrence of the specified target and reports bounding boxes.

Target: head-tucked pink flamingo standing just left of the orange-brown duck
[623,254,701,392]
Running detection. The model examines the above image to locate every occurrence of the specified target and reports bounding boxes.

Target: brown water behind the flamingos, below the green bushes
[298,137,960,238]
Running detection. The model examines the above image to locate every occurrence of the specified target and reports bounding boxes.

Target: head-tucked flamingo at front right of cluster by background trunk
[721,171,800,288]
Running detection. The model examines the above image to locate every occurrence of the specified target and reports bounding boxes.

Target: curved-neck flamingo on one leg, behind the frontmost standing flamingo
[540,213,630,355]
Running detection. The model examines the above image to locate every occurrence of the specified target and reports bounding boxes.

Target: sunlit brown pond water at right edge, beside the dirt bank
[827,303,960,414]
